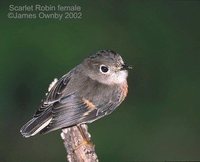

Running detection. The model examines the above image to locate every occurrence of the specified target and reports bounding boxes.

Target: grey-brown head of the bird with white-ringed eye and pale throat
[83,50,132,85]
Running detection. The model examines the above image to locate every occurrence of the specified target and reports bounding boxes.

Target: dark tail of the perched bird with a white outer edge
[20,112,52,138]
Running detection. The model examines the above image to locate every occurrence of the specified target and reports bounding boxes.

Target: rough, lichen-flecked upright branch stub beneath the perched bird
[61,124,99,162]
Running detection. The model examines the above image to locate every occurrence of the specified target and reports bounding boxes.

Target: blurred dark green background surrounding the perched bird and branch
[0,1,200,162]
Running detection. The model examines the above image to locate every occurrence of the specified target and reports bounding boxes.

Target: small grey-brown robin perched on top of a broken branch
[20,50,132,138]
